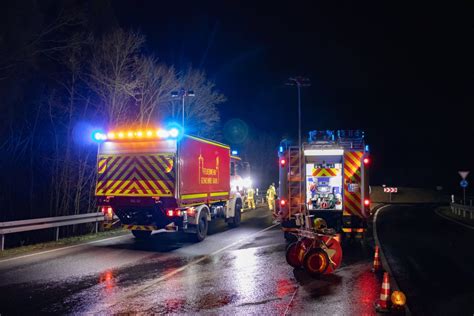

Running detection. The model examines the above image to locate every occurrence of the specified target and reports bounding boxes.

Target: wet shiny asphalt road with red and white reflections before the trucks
[0,208,380,315]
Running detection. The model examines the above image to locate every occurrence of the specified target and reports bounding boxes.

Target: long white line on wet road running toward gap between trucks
[103,224,280,313]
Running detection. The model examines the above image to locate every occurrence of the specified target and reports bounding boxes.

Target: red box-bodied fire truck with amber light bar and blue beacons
[93,128,243,241]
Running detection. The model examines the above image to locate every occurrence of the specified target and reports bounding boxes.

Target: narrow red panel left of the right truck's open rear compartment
[288,147,304,217]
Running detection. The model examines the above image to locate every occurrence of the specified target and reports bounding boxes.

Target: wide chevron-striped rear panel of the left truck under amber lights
[95,154,175,196]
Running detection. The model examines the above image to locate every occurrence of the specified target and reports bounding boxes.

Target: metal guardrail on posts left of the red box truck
[0,212,104,251]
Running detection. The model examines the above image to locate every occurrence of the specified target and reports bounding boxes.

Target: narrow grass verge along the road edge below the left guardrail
[0,228,129,259]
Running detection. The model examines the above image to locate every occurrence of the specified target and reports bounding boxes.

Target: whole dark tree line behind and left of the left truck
[0,1,225,221]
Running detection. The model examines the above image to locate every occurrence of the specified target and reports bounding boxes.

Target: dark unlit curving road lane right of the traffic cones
[377,205,474,316]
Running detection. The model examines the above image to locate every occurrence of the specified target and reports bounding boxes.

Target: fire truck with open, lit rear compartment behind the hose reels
[278,130,370,238]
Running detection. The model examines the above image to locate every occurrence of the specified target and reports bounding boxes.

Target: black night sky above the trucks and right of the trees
[7,0,474,190]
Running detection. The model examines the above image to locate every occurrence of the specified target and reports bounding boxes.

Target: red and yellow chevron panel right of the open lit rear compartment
[344,151,364,217]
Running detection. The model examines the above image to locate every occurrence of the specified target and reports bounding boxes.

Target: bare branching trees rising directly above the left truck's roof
[90,29,225,137]
